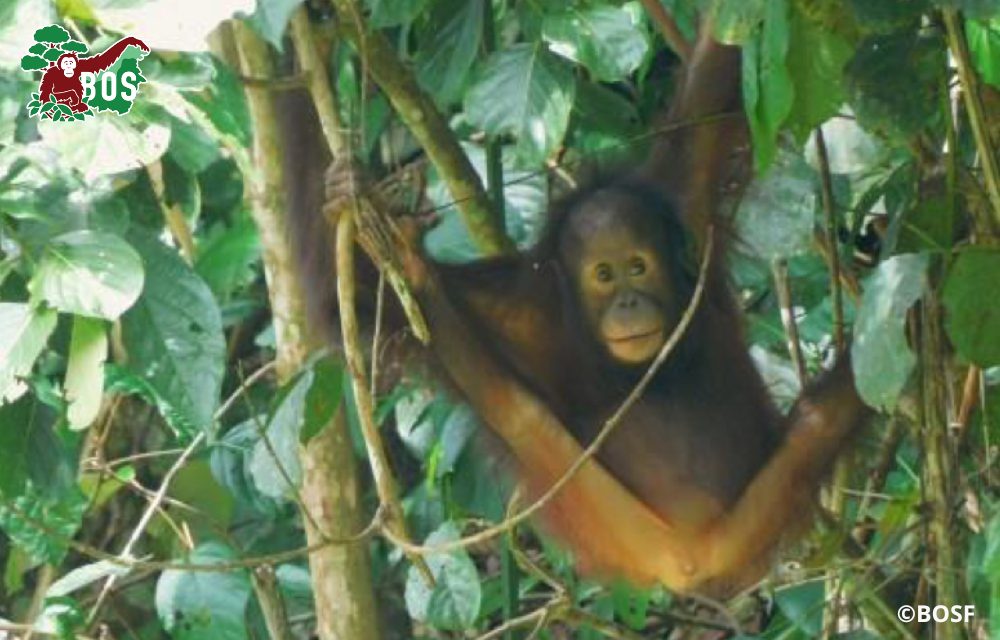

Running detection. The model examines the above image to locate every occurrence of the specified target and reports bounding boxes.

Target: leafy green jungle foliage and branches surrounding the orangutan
[0,0,1000,640]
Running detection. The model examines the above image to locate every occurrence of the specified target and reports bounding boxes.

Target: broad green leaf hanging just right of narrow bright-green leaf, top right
[787,7,852,144]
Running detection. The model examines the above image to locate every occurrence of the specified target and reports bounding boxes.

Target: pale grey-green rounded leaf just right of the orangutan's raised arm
[736,151,819,259]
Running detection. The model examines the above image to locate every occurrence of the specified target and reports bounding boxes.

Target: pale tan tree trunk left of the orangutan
[225,21,378,640]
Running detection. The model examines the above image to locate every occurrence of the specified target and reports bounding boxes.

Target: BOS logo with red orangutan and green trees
[21,24,149,122]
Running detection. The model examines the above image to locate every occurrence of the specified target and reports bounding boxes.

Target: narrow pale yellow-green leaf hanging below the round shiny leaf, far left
[64,316,108,429]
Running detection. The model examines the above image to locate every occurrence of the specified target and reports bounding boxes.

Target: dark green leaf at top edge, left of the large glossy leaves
[416,0,487,105]
